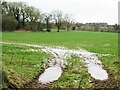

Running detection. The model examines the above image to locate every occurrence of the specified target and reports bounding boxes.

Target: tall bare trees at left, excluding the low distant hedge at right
[0,1,73,32]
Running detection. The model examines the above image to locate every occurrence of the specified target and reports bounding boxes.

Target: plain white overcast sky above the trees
[5,0,120,24]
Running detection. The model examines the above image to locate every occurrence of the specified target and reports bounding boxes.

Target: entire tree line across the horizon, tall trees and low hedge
[0,1,120,32]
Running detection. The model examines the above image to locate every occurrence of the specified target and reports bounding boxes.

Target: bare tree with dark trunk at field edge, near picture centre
[52,10,63,32]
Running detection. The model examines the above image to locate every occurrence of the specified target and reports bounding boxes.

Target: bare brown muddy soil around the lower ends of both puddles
[3,64,120,90]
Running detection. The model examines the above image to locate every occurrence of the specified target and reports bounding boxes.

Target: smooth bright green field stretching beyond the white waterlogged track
[2,31,118,55]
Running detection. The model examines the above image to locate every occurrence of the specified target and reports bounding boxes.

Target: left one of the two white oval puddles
[39,66,62,84]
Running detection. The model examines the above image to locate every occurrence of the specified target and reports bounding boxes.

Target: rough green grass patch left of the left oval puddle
[2,44,50,87]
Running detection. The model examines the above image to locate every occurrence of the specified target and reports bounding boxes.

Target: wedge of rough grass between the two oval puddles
[52,55,92,88]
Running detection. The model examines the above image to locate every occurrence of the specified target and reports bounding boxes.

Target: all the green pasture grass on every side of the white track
[2,31,120,88]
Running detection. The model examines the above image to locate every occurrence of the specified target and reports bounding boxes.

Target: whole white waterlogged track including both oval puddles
[0,42,108,84]
